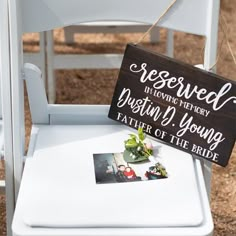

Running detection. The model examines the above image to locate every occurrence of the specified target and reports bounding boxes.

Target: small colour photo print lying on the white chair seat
[93,153,168,184]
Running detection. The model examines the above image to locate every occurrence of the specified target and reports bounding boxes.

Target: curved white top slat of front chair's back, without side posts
[22,0,208,35]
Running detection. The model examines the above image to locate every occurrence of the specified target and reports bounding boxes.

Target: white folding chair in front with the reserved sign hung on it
[9,0,219,236]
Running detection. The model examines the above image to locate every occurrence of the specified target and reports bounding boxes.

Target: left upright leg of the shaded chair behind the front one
[46,31,56,103]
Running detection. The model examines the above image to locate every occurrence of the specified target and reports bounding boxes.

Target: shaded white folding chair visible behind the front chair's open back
[46,23,174,103]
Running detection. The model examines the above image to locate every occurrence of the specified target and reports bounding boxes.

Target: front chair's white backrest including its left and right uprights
[9,0,219,194]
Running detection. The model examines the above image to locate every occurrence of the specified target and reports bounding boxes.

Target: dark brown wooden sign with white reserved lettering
[109,44,236,166]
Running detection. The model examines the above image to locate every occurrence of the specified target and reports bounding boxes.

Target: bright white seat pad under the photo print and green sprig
[17,125,208,228]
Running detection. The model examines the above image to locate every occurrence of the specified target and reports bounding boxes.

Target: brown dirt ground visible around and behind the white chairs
[0,0,236,236]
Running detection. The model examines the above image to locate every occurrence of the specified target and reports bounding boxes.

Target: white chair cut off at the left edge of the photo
[0,0,15,236]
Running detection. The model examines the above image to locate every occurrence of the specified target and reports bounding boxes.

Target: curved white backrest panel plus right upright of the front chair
[18,0,219,69]
